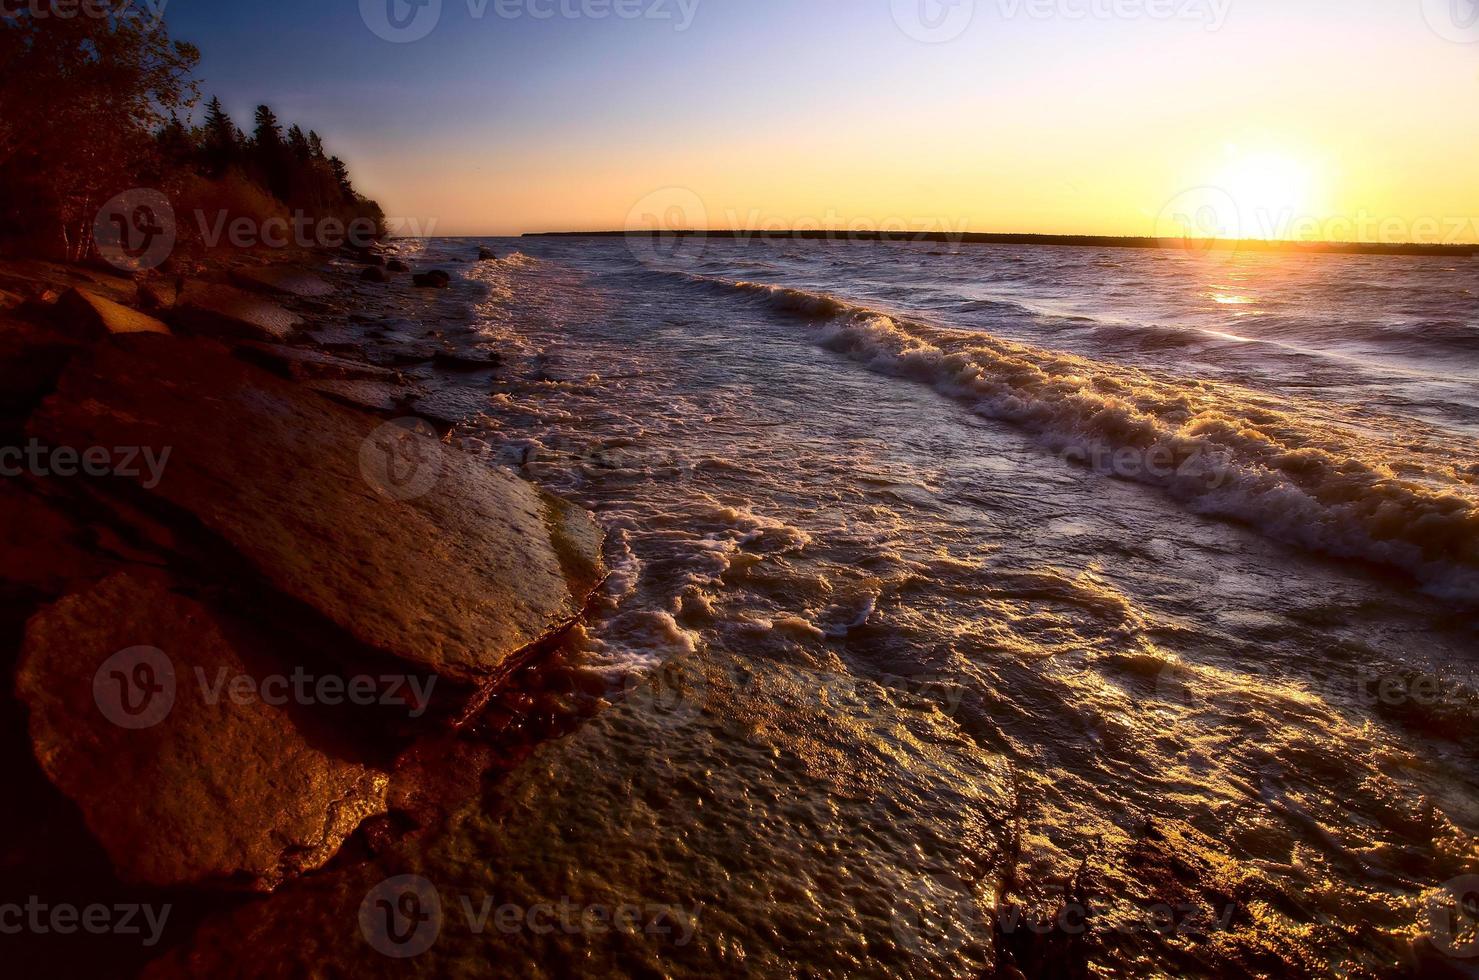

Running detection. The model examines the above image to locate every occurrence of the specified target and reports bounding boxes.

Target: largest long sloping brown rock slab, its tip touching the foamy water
[30,337,603,683]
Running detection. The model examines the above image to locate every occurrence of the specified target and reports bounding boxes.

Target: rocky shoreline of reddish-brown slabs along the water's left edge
[0,247,608,976]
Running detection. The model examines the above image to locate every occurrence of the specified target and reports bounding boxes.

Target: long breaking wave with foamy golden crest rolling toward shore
[676,273,1479,600]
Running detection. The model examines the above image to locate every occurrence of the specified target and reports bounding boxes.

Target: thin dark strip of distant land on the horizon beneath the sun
[522,231,1479,259]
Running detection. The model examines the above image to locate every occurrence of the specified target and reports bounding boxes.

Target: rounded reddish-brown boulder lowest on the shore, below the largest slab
[16,572,389,891]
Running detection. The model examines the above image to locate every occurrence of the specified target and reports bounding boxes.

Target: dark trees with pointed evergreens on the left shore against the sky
[0,0,385,262]
